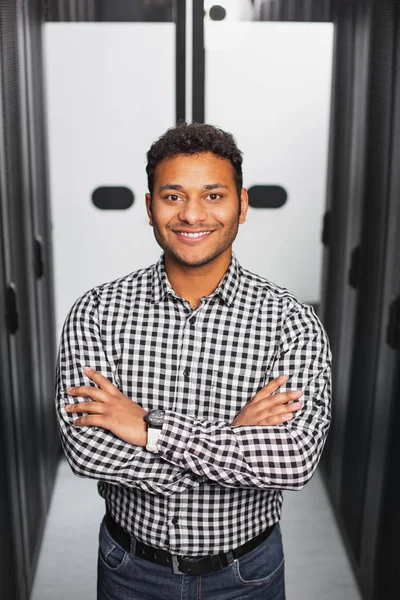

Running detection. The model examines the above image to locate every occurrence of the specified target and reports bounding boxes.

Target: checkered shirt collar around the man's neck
[153,252,241,306]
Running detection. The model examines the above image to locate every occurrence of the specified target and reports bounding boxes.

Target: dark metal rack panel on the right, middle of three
[342,1,395,562]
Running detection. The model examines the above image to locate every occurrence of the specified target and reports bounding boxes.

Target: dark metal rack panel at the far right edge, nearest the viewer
[362,3,400,600]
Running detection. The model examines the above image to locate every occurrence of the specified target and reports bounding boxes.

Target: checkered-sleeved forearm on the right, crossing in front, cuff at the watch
[158,358,330,490]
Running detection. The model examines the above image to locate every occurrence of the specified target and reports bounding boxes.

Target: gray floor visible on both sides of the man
[31,460,361,600]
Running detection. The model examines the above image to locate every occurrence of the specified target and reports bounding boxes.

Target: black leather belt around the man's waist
[105,513,275,575]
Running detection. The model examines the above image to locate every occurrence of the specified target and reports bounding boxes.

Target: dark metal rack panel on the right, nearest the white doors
[320,2,362,486]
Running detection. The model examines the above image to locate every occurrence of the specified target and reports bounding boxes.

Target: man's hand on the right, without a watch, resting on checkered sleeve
[232,375,303,427]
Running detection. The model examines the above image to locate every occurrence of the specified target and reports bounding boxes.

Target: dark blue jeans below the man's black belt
[97,519,285,600]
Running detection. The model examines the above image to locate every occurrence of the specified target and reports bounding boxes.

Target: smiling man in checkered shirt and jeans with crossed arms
[57,124,331,600]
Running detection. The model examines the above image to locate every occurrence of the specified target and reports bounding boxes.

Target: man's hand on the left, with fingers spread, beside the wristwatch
[65,367,147,446]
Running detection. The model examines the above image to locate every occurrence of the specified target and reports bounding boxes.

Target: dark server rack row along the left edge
[0,0,60,600]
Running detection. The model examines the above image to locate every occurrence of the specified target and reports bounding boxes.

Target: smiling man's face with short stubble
[146,152,248,267]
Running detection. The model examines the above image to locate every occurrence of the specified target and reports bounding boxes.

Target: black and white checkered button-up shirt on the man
[56,251,331,556]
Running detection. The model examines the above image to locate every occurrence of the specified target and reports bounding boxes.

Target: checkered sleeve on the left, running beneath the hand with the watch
[56,294,199,495]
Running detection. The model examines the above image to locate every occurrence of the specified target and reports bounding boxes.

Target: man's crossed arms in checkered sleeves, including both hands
[56,290,331,495]
